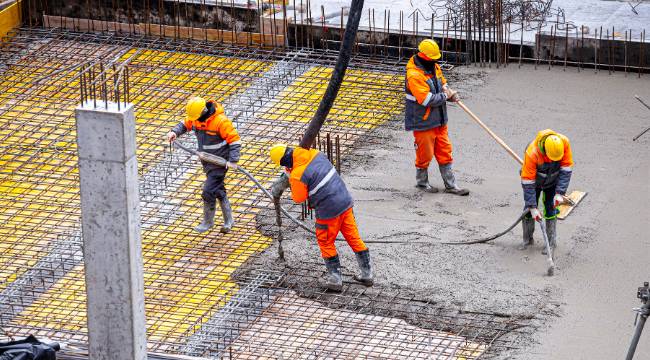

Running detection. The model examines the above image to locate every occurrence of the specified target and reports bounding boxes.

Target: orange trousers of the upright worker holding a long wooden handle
[413,125,453,169]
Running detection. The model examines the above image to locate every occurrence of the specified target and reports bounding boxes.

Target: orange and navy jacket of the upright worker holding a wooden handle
[404,55,447,131]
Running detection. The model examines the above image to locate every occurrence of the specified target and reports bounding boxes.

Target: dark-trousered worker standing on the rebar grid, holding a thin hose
[167,97,241,234]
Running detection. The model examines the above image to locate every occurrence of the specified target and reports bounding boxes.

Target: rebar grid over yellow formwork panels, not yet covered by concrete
[0,28,528,358]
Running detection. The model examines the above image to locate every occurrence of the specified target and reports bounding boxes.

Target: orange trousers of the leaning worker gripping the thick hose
[316,208,368,259]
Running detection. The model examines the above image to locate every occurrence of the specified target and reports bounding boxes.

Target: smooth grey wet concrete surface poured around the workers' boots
[246,65,650,359]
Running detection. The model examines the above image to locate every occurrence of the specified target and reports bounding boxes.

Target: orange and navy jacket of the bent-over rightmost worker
[521,129,573,207]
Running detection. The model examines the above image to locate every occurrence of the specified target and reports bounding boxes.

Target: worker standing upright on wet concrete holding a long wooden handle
[404,39,469,195]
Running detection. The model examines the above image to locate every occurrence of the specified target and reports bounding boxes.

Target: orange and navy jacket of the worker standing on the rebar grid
[172,100,241,171]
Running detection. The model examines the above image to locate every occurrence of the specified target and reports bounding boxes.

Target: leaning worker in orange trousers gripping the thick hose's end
[270,144,373,291]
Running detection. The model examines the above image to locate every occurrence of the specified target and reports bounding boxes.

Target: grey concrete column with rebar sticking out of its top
[75,101,147,360]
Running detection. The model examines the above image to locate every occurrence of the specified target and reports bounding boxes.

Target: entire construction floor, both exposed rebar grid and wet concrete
[0,29,650,359]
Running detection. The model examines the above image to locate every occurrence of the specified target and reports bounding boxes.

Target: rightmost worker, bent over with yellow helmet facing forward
[519,129,573,255]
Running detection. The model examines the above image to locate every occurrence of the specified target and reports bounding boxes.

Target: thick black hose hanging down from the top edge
[299,0,363,149]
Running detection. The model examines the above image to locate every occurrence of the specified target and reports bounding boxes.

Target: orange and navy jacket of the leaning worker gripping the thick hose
[289,147,353,219]
